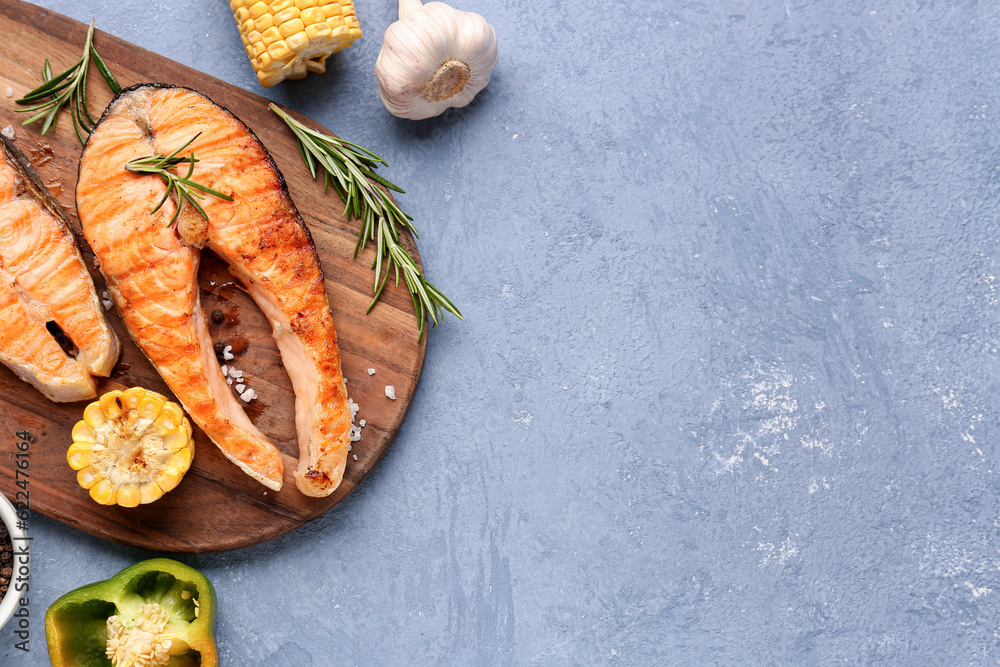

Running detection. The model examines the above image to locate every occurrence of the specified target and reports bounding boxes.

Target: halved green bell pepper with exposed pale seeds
[45,558,219,667]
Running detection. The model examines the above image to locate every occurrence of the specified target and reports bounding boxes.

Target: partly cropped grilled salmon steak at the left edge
[0,136,120,402]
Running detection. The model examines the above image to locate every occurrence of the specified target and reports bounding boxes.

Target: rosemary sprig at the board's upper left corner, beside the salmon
[15,21,122,144]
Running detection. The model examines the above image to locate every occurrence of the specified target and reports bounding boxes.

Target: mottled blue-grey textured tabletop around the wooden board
[0,0,1000,667]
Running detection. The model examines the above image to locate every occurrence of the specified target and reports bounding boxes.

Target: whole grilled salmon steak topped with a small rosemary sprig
[76,84,351,497]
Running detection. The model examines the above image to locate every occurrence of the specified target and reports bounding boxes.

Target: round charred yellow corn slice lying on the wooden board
[66,387,194,507]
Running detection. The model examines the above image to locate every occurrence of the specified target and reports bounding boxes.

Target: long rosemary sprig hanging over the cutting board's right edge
[270,104,464,340]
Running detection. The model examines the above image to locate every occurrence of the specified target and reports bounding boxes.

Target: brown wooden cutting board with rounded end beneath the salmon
[0,0,427,553]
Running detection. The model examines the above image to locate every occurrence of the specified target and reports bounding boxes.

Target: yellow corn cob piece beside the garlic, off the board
[229,0,361,88]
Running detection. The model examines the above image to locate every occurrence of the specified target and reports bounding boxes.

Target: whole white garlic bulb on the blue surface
[375,0,498,120]
